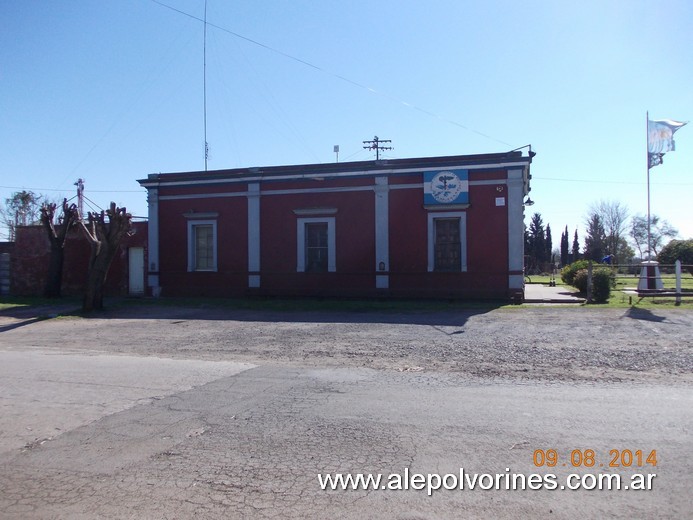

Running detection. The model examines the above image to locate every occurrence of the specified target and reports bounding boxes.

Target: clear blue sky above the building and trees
[0,0,693,245]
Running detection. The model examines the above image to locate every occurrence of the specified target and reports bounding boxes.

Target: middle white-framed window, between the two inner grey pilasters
[296,217,337,273]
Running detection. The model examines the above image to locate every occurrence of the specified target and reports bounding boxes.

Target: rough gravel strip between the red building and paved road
[0,305,693,384]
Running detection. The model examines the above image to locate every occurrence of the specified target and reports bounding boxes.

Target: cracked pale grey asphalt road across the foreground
[0,306,693,520]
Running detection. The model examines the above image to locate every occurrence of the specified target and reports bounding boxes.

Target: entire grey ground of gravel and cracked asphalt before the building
[0,304,693,520]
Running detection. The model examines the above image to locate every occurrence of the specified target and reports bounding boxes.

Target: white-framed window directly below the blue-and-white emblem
[428,212,467,272]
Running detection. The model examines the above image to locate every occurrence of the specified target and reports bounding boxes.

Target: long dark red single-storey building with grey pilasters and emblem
[139,152,534,299]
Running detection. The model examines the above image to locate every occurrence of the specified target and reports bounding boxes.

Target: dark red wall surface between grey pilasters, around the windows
[151,170,508,298]
